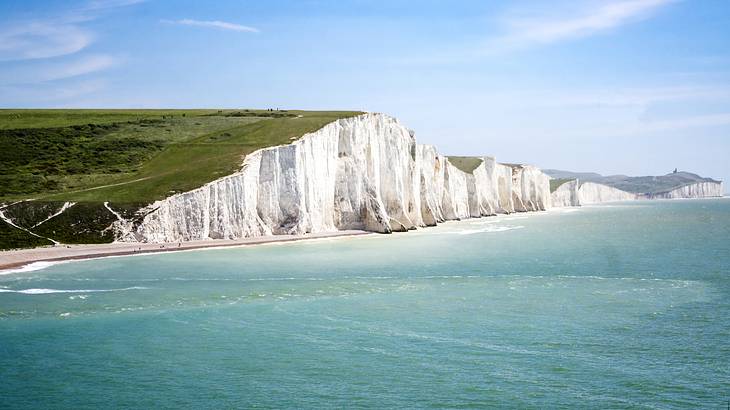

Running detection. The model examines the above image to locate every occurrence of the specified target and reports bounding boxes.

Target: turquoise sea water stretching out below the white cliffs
[0,199,730,409]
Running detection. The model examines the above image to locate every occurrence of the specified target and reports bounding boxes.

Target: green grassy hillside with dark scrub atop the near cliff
[0,109,360,249]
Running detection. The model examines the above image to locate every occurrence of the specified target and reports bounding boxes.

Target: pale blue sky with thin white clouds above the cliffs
[0,0,730,191]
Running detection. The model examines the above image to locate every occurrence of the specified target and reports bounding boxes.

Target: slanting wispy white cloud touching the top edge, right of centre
[485,0,677,53]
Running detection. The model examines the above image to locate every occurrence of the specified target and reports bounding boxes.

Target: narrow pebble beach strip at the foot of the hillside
[0,230,375,274]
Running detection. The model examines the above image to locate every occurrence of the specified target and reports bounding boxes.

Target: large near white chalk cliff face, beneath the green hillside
[123,114,551,242]
